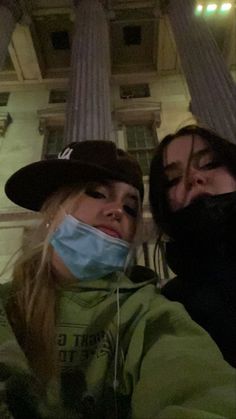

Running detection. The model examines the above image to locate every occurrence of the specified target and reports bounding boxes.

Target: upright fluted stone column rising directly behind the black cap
[65,0,112,143]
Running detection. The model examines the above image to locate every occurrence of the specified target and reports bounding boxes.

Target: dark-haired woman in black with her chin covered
[150,125,236,367]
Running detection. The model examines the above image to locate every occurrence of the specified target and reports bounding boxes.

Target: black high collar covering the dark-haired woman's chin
[166,192,236,273]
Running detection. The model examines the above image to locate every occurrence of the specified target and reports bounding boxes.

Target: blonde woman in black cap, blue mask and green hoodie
[0,141,236,419]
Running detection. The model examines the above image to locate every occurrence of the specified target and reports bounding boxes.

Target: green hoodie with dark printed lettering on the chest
[0,269,236,419]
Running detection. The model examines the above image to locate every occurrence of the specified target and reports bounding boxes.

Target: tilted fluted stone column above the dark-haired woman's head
[167,0,236,143]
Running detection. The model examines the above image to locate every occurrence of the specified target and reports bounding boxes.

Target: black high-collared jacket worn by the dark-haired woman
[162,193,236,367]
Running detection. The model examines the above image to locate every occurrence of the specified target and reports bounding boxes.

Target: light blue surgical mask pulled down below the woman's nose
[50,215,130,280]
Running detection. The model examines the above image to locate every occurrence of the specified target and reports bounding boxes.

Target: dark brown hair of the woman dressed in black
[149,125,236,234]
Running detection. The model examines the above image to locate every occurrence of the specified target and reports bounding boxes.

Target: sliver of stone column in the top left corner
[0,0,22,70]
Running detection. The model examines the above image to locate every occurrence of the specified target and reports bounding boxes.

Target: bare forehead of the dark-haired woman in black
[164,135,209,166]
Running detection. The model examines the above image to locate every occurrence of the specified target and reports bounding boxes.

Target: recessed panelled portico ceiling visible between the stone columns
[0,0,236,89]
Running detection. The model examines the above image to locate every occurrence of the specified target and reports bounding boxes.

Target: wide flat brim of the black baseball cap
[5,159,122,211]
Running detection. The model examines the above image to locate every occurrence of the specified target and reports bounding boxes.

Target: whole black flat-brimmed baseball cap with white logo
[5,140,144,211]
